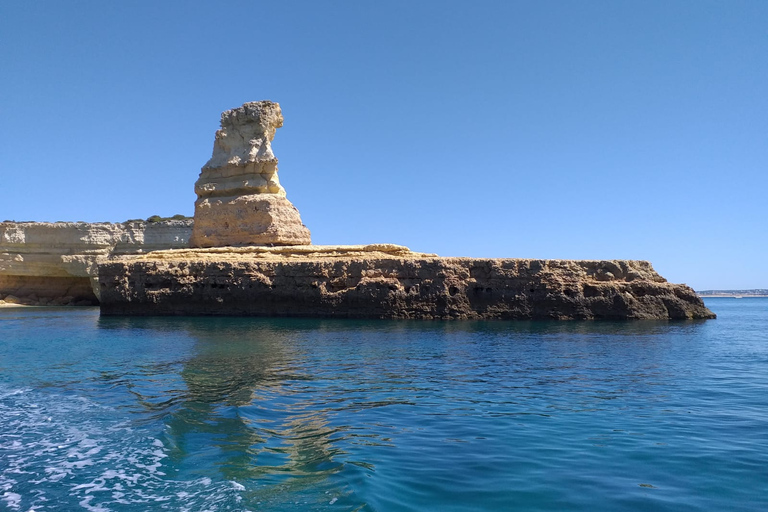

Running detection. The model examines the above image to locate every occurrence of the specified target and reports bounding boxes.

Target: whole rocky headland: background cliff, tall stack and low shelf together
[0,101,715,320]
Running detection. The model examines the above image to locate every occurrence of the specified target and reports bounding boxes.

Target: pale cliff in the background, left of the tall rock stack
[0,220,192,305]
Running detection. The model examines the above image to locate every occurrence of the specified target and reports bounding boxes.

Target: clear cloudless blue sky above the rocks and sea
[0,0,768,290]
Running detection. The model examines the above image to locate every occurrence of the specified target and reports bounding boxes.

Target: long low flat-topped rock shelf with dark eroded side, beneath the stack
[99,246,715,320]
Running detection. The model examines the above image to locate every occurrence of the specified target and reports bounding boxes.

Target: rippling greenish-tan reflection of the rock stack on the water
[166,322,343,483]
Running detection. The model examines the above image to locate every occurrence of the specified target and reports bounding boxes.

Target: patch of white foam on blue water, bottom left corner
[0,387,260,512]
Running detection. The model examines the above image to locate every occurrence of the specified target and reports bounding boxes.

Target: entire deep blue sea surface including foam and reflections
[0,298,768,512]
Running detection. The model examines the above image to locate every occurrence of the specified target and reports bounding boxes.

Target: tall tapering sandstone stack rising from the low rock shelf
[190,101,310,247]
